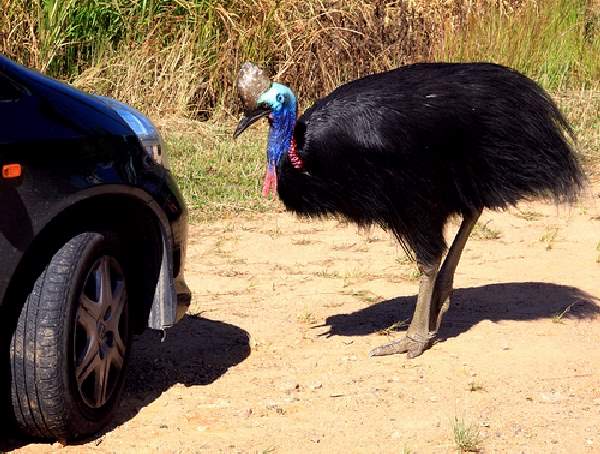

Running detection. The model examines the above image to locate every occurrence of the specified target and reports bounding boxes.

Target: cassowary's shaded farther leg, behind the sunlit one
[429,210,481,332]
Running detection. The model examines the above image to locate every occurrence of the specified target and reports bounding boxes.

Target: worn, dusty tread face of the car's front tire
[10,232,109,440]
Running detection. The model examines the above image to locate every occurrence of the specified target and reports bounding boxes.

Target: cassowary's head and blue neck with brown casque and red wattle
[233,63,296,196]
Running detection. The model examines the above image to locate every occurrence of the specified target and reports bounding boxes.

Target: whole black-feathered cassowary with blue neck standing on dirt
[234,63,583,358]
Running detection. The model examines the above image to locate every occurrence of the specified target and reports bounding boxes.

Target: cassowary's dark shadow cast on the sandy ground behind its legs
[324,282,600,341]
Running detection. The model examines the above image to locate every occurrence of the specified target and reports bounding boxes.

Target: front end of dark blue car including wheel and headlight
[0,56,190,440]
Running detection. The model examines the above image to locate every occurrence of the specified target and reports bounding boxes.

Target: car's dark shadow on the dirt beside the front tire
[0,315,250,452]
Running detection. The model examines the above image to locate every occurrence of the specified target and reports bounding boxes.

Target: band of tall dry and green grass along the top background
[0,0,600,117]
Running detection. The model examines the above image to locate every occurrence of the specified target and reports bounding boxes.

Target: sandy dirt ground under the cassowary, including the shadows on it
[4,186,600,453]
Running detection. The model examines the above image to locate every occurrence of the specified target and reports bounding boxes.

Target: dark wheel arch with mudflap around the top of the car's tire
[2,185,176,332]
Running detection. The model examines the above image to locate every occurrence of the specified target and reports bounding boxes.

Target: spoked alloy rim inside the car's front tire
[74,255,127,408]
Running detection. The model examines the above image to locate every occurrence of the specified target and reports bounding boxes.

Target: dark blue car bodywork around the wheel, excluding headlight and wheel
[0,56,189,329]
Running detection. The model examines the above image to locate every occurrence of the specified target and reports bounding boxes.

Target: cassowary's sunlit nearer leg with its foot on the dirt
[369,258,440,358]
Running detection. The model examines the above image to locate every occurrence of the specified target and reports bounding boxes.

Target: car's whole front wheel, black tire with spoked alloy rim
[10,232,131,440]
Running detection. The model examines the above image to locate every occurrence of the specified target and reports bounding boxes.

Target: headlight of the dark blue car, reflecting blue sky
[100,96,167,167]
